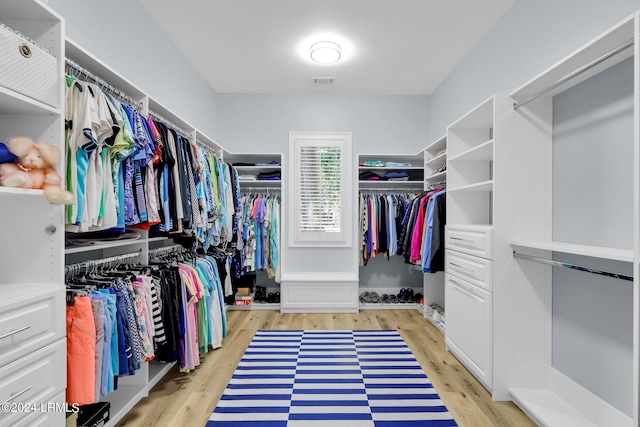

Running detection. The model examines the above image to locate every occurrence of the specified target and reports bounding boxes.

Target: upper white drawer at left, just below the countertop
[0,283,66,366]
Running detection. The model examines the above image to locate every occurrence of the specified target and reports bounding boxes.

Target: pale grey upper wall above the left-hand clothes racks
[49,0,218,140]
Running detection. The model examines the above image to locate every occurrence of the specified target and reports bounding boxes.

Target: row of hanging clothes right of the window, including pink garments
[359,187,446,273]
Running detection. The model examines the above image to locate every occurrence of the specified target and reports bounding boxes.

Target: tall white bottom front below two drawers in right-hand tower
[445,273,493,389]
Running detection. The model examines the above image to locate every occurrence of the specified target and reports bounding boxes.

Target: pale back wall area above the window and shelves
[218,93,429,153]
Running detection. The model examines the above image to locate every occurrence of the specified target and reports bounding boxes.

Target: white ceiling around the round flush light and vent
[138,0,515,94]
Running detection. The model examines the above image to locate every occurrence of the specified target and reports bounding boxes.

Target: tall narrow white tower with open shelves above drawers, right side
[445,94,511,391]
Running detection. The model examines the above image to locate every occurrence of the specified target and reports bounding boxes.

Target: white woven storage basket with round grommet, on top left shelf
[0,24,58,107]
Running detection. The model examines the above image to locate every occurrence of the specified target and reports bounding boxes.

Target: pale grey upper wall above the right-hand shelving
[429,0,640,140]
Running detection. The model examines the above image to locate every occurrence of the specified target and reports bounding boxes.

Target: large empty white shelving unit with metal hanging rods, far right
[493,14,640,426]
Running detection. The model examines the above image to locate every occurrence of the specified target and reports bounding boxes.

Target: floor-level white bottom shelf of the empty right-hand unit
[509,388,597,427]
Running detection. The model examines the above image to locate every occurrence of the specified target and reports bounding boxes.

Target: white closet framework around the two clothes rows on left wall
[59,39,222,427]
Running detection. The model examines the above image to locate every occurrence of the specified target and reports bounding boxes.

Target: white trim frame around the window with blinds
[288,132,353,247]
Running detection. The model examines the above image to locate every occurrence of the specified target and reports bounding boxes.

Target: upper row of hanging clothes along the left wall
[65,61,240,251]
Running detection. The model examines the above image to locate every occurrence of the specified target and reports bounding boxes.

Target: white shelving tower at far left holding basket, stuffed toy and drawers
[0,0,66,425]
